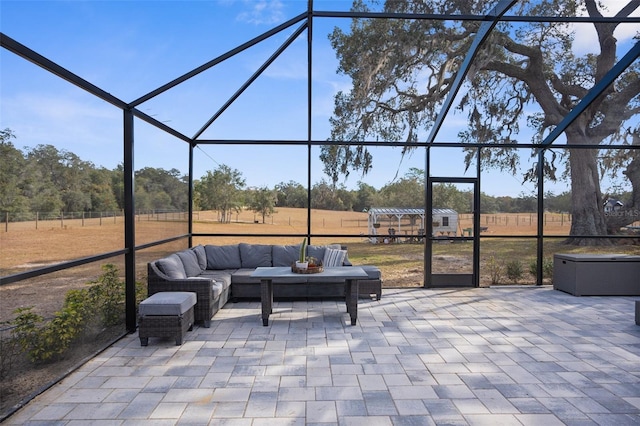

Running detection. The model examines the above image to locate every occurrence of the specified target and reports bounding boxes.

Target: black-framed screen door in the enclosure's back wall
[424,178,480,288]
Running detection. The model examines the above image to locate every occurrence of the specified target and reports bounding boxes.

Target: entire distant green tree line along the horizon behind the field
[0,129,624,222]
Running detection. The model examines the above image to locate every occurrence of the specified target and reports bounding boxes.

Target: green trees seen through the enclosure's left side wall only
[0,129,188,218]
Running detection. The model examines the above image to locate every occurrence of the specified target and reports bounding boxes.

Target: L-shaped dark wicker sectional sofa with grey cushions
[147,243,382,327]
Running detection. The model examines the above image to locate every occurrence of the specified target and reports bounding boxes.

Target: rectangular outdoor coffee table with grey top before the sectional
[251,266,368,327]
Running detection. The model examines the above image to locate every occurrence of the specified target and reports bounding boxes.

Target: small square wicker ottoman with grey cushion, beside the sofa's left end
[138,291,196,346]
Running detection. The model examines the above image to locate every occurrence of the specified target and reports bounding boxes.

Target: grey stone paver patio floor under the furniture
[5,286,640,426]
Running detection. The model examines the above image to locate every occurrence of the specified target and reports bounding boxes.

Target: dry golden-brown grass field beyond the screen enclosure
[0,208,570,275]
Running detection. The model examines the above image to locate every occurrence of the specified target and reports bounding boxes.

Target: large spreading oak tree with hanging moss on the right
[321,0,640,244]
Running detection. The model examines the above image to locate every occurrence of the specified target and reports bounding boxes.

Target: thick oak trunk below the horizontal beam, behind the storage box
[566,145,611,246]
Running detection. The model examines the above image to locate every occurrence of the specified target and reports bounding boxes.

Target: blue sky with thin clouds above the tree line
[0,0,636,196]
